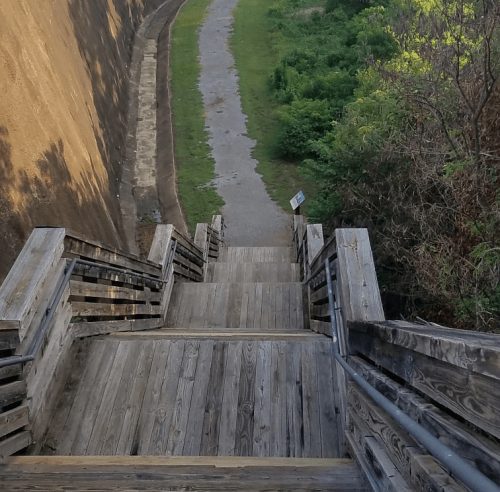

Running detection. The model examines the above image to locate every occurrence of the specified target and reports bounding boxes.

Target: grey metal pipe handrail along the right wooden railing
[325,260,500,492]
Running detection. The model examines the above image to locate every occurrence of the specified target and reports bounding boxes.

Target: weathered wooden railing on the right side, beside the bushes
[292,219,500,492]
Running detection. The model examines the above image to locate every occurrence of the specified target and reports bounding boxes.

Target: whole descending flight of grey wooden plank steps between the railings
[7,244,367,491]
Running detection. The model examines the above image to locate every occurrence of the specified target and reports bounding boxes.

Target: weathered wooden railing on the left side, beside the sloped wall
[0,218,220,456]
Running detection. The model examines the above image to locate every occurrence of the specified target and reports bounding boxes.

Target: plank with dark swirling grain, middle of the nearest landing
[234,341,257,456]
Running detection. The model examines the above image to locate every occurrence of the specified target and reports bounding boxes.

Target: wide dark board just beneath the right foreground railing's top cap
[349,324,500,438]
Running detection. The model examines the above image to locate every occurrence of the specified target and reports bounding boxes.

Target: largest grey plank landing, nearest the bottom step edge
[40,333,341,458]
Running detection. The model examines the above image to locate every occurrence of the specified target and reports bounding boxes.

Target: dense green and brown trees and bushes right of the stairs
[271,0,500,330]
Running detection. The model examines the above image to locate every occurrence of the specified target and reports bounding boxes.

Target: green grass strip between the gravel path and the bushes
[231,0,315,215]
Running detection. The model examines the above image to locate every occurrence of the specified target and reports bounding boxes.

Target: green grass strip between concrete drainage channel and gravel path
[171,0,224,232]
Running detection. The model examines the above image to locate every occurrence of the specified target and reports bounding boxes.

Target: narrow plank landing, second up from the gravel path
[205,262,300,283]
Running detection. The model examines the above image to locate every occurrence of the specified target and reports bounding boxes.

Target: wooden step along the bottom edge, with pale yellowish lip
[0,456,367,492]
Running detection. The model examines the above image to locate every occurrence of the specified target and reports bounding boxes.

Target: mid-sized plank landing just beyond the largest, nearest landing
[165,282,307,330]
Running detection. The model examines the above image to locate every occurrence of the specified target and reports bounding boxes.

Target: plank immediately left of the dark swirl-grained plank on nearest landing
[218,341,243,456]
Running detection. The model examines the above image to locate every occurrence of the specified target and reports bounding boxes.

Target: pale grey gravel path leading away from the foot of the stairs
[199,0,291,246]
